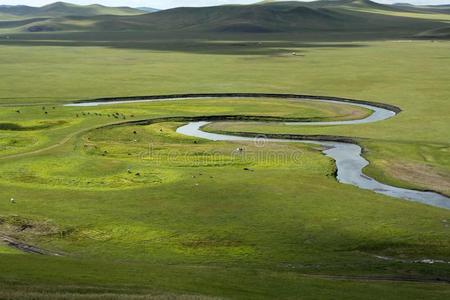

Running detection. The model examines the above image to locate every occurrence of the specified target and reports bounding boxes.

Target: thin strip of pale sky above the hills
[0,0,450,9]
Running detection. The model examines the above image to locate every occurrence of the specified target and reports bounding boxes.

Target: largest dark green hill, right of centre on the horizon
[125,0,450,34]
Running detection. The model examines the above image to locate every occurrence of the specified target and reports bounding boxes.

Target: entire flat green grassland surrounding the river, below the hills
[0,2,450,299]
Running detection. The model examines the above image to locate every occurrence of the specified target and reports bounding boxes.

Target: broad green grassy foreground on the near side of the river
[0,116,450,298]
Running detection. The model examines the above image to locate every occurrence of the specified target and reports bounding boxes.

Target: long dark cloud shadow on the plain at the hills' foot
[0,32,366,55]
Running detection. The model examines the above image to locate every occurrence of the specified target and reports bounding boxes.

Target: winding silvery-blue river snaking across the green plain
[67,94,450,209]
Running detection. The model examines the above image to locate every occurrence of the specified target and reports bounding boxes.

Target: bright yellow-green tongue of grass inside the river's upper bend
[0,98,370,159]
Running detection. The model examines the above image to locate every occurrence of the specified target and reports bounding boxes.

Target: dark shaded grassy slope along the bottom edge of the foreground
[0,257,448,299]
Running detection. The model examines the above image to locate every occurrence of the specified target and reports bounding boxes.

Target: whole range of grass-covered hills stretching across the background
[0,0,450,39]
